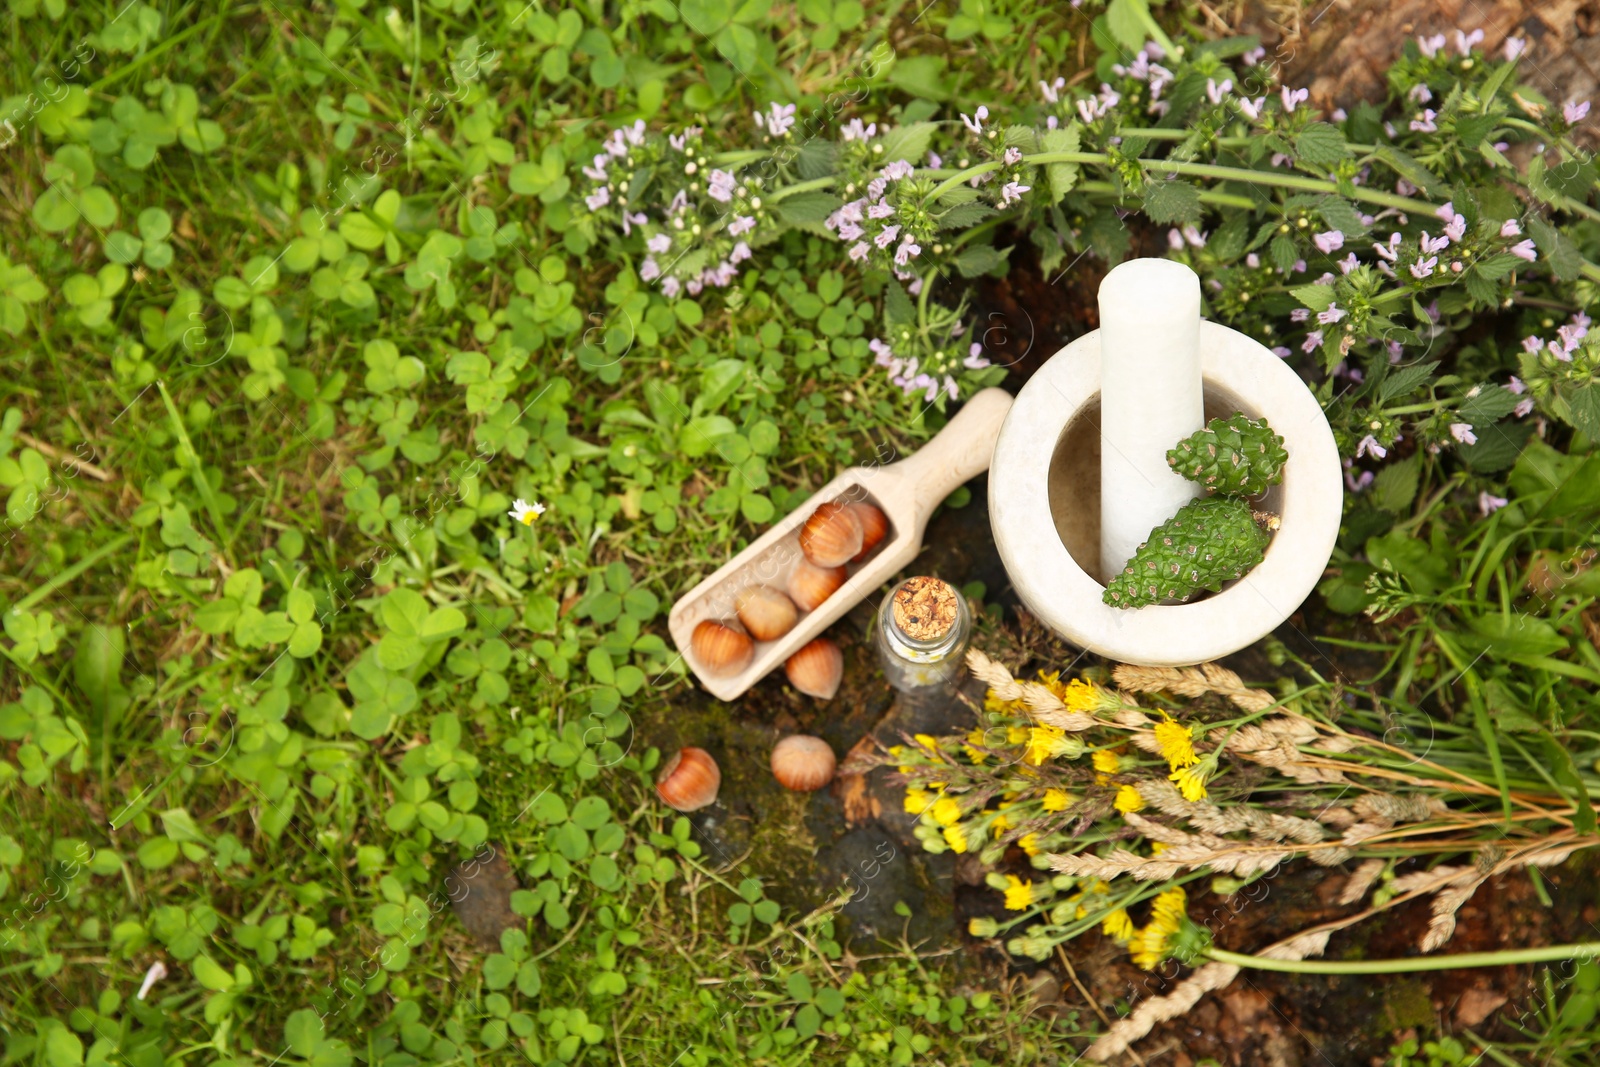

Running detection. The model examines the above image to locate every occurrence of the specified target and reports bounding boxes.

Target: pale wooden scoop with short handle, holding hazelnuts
[667,389,1017,701]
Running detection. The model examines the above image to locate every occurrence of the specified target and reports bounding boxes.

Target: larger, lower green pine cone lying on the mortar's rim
[1101,496,1267,608]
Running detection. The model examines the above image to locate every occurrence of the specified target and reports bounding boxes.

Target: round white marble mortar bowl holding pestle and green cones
[989,322,1344,667]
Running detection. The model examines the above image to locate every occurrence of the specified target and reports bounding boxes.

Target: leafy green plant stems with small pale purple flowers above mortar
[579,26,1600,441]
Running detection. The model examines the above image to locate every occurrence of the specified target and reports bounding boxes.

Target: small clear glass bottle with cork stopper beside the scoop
[877,577,973,693]
